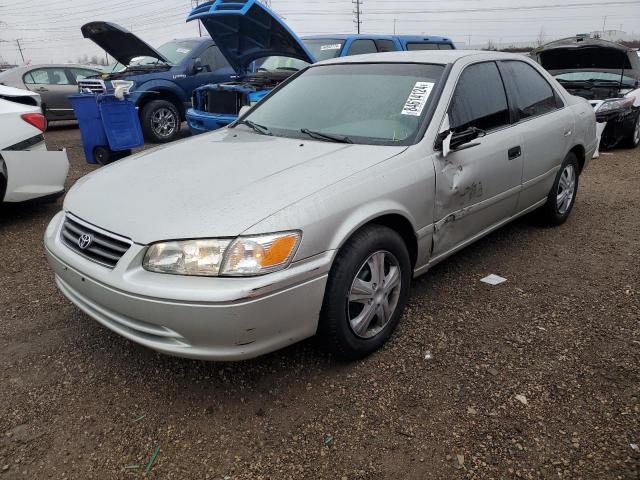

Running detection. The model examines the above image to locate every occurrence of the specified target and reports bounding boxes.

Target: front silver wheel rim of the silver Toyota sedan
[347,251,402,339]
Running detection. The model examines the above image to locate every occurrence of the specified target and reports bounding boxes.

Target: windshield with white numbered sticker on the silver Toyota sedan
[246,63,444,145]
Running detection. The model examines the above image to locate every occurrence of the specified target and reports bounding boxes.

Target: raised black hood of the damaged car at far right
[531,37,640,78]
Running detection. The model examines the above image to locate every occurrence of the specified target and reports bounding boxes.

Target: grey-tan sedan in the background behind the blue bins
[0,64,101,121]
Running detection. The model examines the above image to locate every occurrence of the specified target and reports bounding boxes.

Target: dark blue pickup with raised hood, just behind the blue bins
[78,22,236,143]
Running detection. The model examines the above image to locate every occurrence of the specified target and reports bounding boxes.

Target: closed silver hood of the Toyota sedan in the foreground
[64,127,406,244]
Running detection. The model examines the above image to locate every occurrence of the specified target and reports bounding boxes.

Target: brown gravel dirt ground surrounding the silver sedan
[0,122,640,480]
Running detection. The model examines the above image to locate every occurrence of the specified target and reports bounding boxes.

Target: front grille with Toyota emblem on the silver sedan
[60,215,132,268]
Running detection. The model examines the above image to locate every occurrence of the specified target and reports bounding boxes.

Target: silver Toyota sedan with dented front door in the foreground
[45,51,596,360]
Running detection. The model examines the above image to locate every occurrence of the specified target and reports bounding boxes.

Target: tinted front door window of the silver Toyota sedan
[449,62,509,131]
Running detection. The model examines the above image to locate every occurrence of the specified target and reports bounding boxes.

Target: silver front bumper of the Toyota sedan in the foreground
[45,212,331,361]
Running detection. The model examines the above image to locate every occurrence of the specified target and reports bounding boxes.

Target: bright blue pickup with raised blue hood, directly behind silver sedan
[187,0,455,134]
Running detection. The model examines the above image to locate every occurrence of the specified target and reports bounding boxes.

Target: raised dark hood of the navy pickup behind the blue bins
[80,22,170,65]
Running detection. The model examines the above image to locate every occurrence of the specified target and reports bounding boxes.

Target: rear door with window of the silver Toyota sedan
[499,60,574,210]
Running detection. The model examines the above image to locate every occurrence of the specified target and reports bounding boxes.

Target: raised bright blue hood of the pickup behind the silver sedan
[187,0,315,73]
